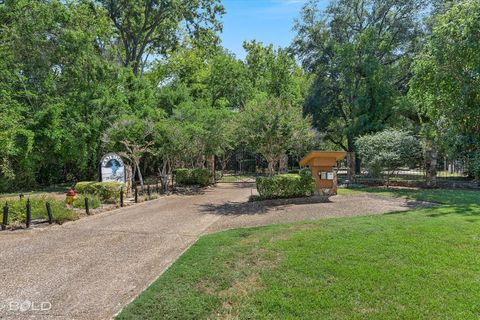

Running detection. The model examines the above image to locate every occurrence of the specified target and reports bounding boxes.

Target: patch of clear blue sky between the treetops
[221,0,328,59]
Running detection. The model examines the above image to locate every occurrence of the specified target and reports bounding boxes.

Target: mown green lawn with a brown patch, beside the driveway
[118,189,480,319]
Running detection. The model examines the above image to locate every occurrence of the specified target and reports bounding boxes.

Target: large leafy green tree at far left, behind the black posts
[0,0,126,184]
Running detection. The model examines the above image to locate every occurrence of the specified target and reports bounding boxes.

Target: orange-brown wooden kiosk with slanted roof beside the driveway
[300,151,347,195]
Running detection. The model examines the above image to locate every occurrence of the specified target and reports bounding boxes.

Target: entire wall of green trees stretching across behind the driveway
[0,0,480,191]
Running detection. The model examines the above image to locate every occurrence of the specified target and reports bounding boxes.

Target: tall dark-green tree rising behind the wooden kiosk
[292,0,425,170]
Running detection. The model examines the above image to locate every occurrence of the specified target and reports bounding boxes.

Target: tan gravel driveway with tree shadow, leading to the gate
[0,184,418,320]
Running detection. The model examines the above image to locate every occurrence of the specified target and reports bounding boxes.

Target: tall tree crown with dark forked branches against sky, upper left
[98,0,224,75]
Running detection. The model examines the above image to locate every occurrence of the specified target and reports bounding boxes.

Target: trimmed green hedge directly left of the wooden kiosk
[256,169,315,200]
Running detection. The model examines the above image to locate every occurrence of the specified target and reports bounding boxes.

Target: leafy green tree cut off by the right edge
[411,0,480,178]
